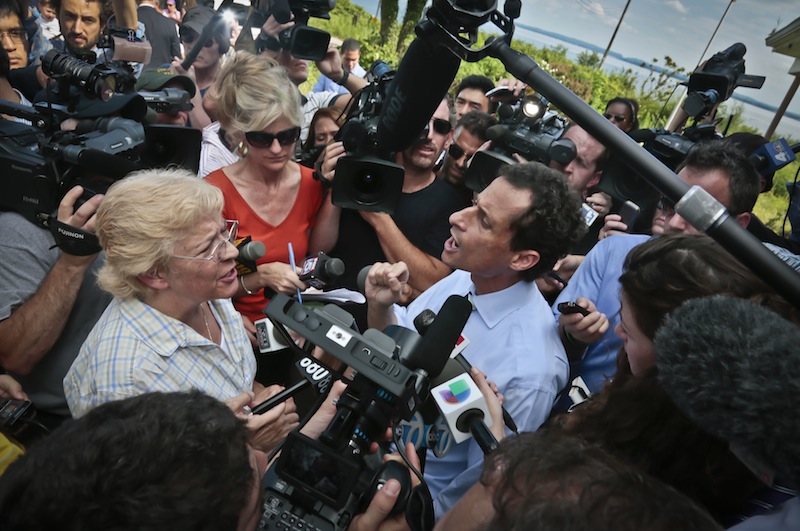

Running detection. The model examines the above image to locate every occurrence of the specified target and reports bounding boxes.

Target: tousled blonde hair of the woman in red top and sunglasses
[209,52,303,143]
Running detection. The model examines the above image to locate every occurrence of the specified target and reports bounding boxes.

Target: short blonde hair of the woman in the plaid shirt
[97,169,224,299]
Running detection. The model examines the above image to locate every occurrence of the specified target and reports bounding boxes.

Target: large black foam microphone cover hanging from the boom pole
[377,38,461,151]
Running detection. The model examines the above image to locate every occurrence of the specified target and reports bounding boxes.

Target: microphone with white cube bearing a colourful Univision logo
[431,360,497,454]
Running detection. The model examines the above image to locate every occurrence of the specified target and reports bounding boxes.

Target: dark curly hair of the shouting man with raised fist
[500,162,586,282]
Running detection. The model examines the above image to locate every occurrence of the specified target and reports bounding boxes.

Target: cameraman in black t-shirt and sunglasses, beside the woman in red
[321,97,464,330]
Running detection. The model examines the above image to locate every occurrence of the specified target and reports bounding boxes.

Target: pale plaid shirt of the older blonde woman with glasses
[64,298,256,417]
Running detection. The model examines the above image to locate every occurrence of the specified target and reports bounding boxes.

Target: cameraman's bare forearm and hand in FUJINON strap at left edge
[0,186,103,375]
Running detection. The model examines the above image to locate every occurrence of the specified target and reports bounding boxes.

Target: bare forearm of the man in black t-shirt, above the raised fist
[361,212,453,292]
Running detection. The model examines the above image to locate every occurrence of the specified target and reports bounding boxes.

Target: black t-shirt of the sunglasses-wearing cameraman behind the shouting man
[330,179,466,330]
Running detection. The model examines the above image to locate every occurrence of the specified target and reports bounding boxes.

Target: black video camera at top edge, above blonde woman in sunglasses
[253,0,336,61]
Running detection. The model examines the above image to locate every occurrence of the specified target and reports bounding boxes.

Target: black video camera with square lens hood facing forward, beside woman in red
[331,61,404,214]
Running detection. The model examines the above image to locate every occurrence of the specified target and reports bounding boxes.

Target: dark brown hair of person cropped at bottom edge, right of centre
[481,428,721,531]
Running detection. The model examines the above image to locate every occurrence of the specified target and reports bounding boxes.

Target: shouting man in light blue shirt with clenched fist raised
[366,162,584,516]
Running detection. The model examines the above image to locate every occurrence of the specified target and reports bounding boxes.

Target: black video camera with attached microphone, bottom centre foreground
[259,294,469,530]
